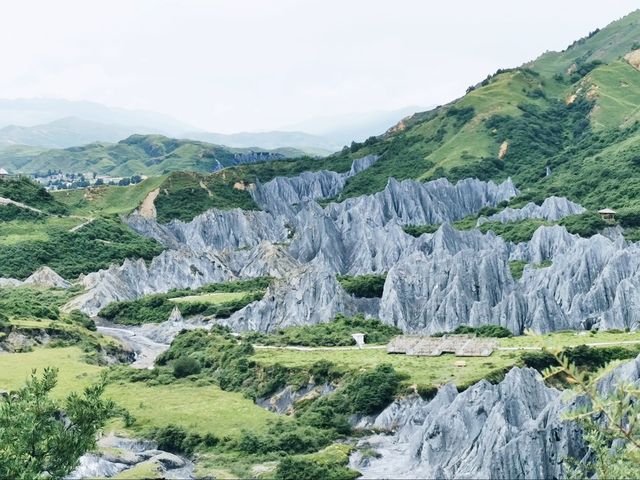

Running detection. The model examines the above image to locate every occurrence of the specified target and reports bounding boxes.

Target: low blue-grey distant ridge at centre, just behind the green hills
[184,130,343,156]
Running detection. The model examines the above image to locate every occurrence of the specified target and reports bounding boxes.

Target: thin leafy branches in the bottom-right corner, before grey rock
[544,353,640,479]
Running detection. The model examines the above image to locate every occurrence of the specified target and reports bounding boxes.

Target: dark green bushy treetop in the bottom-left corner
[0,368,117,480]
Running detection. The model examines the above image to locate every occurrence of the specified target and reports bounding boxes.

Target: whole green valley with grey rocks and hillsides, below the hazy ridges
[0,7,640,480]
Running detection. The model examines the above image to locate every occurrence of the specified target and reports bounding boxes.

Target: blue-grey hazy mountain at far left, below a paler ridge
[0,117,152,148]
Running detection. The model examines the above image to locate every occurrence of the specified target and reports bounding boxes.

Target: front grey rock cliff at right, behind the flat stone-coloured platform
[380,226,640,334]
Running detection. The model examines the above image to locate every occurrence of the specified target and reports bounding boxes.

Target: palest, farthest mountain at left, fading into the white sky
[0,98,196,138]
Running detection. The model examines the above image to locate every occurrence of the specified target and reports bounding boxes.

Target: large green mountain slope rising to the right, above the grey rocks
[312,11,640,209]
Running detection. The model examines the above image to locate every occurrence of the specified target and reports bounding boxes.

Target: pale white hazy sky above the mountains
[0,0,640,132]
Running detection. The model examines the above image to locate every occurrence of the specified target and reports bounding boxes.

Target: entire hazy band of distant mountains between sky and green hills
[0,99,430,156]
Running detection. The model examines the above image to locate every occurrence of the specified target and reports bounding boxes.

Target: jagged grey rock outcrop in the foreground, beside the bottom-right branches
[351,368,585,479]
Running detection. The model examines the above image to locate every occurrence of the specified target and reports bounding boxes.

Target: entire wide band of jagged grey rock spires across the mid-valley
[61,157,640,333]
